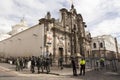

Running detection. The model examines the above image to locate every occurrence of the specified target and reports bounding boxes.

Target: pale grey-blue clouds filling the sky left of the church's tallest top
[0,0,66,32]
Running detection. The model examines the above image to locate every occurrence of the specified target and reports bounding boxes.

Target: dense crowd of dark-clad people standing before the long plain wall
[15,56,52,73]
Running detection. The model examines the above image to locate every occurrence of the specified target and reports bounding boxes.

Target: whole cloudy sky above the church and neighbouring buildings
[0,0,120,43]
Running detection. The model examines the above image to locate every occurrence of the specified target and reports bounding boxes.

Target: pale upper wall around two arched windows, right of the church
[91,35,116,52]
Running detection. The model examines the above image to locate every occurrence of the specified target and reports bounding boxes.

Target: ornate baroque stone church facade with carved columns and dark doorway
[39,5,91,61]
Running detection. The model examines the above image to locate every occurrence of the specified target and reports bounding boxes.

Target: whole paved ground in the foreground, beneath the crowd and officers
[0,63,120,80]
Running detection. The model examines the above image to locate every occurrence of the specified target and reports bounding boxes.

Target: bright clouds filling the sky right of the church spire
[75,0,120,36]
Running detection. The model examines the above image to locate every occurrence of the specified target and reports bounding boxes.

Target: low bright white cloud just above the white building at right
[91,17,120,36]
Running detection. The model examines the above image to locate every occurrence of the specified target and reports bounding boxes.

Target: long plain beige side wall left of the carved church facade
[0,25,44,56]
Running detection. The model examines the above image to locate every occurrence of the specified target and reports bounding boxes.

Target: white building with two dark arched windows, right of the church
[91,35,117,58]
